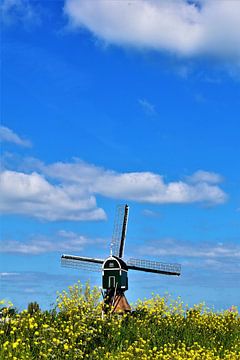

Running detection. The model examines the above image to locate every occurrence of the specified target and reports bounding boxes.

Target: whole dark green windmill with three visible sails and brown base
[61,205,181,312]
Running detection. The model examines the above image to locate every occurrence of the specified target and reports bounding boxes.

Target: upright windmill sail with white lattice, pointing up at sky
[111,205,129,258]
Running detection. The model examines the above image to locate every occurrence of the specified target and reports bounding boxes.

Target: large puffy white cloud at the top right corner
[65,0,240,59]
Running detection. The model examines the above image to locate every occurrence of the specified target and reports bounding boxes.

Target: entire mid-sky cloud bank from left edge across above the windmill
[0,158,227,221]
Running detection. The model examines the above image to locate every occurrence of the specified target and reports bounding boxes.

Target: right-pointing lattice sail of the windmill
[127,259,181,275]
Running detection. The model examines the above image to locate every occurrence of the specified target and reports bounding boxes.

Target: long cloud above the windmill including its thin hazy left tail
[41,160,227,204]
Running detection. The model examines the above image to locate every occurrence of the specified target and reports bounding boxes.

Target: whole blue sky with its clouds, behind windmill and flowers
[0,0,240,309]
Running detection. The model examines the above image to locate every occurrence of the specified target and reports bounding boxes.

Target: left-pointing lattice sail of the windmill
[61,255,104,271]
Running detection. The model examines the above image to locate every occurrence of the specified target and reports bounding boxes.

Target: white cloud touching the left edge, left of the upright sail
[0,170,105,221]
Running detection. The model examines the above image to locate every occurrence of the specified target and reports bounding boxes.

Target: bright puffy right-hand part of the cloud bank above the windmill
[95,172,226,204]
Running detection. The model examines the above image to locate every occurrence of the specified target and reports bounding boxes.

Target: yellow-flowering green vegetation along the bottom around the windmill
[0,283,240,360]
